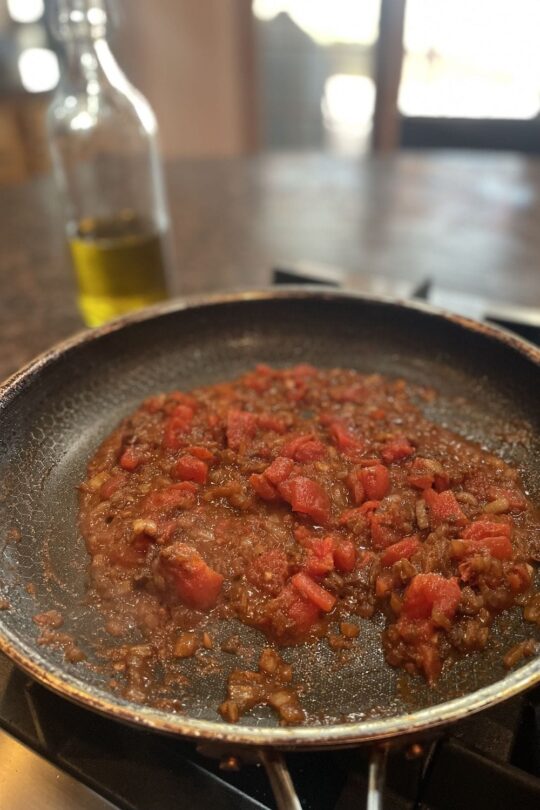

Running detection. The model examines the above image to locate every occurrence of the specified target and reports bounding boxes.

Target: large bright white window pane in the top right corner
[399,0,540,119]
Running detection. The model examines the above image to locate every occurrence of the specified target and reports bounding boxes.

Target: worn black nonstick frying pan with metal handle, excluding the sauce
[0,288,540,807]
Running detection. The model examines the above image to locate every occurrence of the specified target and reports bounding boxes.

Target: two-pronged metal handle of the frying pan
[259,747,387,810]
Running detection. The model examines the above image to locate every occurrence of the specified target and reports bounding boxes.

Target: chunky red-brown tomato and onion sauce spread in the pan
[80,365,540,723]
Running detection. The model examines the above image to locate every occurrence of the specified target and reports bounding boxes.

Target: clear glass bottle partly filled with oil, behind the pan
[48,0,170,326]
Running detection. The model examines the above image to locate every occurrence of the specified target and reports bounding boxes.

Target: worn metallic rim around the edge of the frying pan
[0,286,540,748]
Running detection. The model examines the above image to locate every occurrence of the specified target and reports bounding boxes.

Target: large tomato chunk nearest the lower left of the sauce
[158,543,223,610]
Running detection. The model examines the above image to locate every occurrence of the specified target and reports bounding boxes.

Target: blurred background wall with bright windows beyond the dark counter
[0,0,540,183]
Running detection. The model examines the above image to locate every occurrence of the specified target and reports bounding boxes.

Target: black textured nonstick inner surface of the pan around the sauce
[0,292,540,727]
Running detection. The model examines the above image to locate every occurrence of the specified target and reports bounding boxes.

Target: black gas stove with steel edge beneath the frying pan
[0,274,540,810]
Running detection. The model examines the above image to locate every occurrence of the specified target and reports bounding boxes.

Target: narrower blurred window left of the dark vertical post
[253,0,380,154]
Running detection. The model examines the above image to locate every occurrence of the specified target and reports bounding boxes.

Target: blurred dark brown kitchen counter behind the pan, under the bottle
[0,152,540,379]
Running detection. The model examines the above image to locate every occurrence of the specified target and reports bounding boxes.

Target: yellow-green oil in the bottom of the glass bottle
[69,211,167,326]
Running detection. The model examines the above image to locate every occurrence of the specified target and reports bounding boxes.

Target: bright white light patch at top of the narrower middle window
[252,0,381,45]
